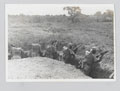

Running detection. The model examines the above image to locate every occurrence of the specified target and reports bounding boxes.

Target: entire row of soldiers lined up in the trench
[8,41,108,75]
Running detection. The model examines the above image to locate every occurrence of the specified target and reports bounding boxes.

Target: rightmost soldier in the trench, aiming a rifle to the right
[81,47,107,76]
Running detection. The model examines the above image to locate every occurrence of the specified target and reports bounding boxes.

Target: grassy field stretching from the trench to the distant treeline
[8,16,114,78]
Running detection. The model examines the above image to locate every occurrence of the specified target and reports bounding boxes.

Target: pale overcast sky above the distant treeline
[6,4,114,15]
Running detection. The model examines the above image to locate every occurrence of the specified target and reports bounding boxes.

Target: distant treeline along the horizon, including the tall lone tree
[8,7,114,23]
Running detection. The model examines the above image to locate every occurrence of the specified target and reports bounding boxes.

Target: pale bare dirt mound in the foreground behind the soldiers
[8,57,91,79]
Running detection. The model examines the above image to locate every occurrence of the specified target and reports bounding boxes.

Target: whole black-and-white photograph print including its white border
[5,4,116,82]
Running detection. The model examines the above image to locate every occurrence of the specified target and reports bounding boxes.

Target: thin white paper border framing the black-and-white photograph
[5,4,117,82]
